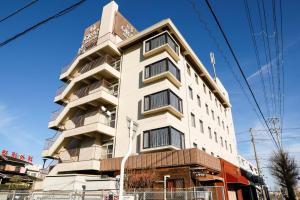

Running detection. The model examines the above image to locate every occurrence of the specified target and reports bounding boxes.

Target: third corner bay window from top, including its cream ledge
[143,89,183,118]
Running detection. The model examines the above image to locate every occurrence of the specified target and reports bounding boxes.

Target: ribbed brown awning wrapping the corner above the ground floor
[100,148,221,172]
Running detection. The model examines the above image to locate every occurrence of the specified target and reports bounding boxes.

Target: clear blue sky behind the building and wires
[0,0,300,187]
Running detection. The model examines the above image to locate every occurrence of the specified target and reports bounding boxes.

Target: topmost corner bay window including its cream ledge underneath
[143,31,180,62]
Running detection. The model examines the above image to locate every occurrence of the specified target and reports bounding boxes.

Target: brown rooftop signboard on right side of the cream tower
[114,12,137,40]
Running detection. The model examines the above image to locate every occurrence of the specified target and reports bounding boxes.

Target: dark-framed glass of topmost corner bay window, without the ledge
[145,32,179,54]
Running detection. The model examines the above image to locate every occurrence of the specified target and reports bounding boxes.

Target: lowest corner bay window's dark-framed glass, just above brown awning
[143,126,184,149]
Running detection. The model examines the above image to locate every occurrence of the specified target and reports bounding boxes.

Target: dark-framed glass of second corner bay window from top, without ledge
[145,58,180,81]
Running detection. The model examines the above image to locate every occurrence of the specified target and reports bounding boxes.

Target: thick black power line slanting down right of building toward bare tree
[205,0,279,149]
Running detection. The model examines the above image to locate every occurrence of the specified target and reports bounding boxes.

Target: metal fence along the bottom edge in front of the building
[0,186,225,200]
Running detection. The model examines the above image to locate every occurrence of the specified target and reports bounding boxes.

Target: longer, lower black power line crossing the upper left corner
[0,0,86,47]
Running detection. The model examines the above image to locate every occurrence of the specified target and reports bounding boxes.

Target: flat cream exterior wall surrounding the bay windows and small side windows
[115,32,238,165]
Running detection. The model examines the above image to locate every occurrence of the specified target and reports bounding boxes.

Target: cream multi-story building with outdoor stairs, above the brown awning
[43,1,238,191]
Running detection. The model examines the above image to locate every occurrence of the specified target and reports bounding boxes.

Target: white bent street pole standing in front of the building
[119,117,138,200]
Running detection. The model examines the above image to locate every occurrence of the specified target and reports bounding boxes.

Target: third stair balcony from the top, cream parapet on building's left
[48,80,118,129]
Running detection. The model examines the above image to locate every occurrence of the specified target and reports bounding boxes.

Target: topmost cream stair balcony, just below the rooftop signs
[60,33,121,81]
